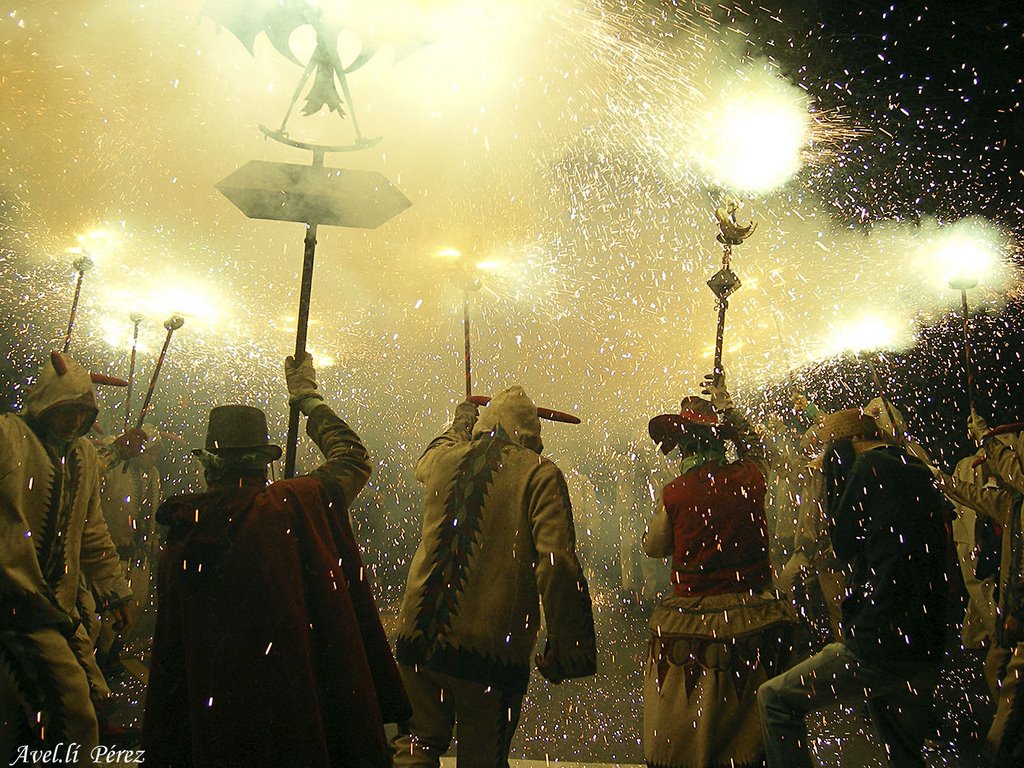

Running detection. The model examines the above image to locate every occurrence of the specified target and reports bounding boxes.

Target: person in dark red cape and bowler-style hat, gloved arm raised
[142,354,411,768]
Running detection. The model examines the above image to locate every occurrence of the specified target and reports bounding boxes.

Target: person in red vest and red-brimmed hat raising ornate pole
[643,374,806,768]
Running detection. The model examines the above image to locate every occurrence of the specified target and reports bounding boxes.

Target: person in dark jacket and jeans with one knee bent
[758,409,948,768]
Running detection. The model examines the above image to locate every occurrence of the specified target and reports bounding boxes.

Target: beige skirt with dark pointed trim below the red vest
[643,592,808,768]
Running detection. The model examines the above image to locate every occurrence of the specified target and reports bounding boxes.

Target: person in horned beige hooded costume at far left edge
[0,352,135,762]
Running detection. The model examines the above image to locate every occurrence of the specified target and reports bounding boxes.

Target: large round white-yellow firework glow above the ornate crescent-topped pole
[692,67,811,193]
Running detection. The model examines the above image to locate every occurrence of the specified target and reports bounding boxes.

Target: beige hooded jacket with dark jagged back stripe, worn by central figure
[396,387,596,694]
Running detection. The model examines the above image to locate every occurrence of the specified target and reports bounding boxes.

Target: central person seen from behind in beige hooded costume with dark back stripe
[394,387,596,768]
